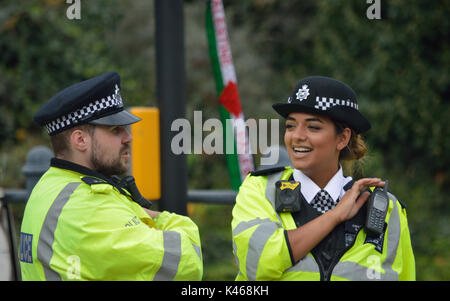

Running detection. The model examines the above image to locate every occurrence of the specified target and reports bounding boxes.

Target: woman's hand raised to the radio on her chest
[331,178,385,224]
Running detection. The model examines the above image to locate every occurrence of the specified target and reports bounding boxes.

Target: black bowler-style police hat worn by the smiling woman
[272,76,370,133]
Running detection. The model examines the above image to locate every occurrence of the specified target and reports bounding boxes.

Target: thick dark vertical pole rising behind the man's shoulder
[155,0,187,215]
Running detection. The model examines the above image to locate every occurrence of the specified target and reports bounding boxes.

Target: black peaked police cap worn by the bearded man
[33,71,141,136]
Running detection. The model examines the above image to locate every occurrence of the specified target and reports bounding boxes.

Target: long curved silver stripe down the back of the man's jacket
[37,182,81,281]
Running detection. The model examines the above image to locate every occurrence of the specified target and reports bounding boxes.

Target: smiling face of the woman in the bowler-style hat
[284,112,350,179]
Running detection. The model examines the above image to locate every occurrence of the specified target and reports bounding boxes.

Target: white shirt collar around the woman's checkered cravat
[293,164,352,203]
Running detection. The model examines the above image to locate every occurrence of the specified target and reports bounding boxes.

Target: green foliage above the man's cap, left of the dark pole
[0,0,155,141]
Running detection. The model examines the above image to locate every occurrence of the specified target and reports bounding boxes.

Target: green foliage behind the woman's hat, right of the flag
[227,0,450,179]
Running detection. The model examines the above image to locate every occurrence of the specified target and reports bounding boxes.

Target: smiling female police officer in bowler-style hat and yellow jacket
[232,76,415,280]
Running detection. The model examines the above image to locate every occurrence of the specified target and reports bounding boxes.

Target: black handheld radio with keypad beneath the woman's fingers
[365,180,389,236]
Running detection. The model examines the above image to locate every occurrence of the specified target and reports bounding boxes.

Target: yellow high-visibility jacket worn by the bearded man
[19,161,203,280]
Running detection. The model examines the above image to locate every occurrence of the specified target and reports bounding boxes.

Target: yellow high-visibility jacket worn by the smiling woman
[231,167,415,280]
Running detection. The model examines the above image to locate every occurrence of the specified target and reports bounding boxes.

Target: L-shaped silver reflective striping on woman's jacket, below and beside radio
[333,193,400,281]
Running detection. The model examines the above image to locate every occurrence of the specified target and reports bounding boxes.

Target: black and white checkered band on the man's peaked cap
[45,85,123,135]
